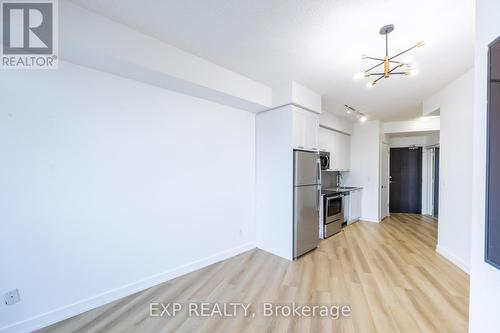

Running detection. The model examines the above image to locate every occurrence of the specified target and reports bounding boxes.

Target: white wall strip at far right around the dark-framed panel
[469,0,500,333]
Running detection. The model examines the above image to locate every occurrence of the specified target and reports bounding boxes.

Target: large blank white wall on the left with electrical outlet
[0,62,256,331]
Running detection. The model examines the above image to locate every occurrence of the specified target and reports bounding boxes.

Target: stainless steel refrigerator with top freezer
[293,150,321,259]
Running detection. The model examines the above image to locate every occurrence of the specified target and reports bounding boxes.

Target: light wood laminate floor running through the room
[38,214,469,333]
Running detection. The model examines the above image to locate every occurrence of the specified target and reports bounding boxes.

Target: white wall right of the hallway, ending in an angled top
[424,70,474,272]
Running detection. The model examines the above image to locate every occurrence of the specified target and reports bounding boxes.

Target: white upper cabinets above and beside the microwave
[319,128,351,171]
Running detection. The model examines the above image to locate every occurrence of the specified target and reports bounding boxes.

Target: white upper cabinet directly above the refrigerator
[292,107,319,150]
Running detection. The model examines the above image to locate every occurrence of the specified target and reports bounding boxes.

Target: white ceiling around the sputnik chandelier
[69,0,474,120]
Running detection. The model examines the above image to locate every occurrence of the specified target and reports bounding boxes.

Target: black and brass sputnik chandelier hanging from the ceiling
[355,24,425,88]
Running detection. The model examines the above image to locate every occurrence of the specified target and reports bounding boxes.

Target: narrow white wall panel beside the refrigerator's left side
[256,105,294,260]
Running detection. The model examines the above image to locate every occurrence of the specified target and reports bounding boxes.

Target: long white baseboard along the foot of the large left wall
[0,243,255,333]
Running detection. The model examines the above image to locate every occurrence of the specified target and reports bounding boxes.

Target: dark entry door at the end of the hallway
[389,147,422,214]
